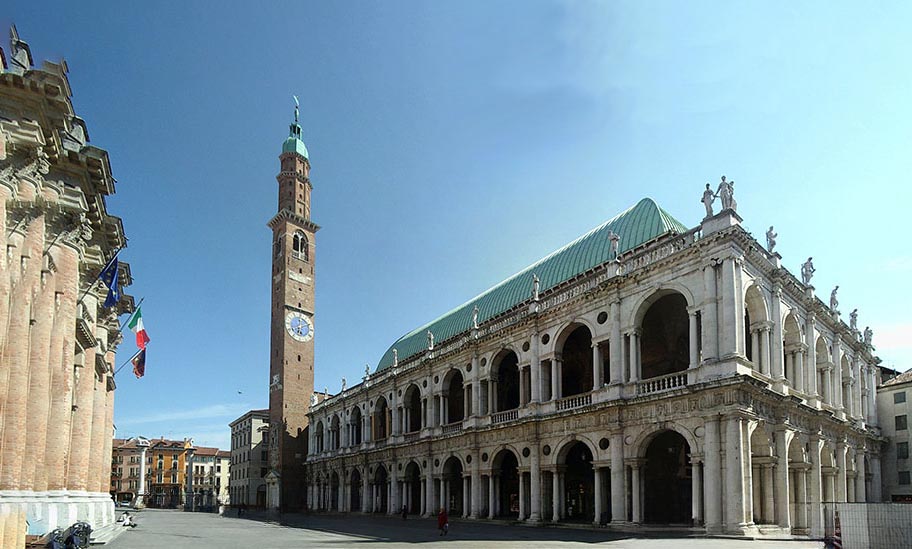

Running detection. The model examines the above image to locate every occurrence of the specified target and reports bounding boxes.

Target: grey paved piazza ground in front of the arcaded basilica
[108,509,823,549]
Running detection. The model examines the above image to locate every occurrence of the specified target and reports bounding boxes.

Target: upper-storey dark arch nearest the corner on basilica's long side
[640,293,690,379]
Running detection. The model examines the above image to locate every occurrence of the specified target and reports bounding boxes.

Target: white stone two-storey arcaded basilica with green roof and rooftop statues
[306,178,883,536]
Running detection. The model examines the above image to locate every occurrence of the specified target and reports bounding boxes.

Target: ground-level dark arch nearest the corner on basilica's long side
[643,431,692,524]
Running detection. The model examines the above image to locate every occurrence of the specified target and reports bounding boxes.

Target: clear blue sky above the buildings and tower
[7,0,912,448]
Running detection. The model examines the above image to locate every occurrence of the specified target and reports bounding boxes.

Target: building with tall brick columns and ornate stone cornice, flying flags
[0,28,133,547]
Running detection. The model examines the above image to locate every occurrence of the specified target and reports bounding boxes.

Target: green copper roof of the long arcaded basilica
[377,198,688,371]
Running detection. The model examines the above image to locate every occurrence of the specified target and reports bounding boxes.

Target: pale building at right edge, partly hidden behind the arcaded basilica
[877,370,912,503]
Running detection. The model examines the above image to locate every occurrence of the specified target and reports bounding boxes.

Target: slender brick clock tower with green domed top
[266,98,320,509]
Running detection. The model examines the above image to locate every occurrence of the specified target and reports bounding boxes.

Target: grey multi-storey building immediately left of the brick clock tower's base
[228,410,270,507]
